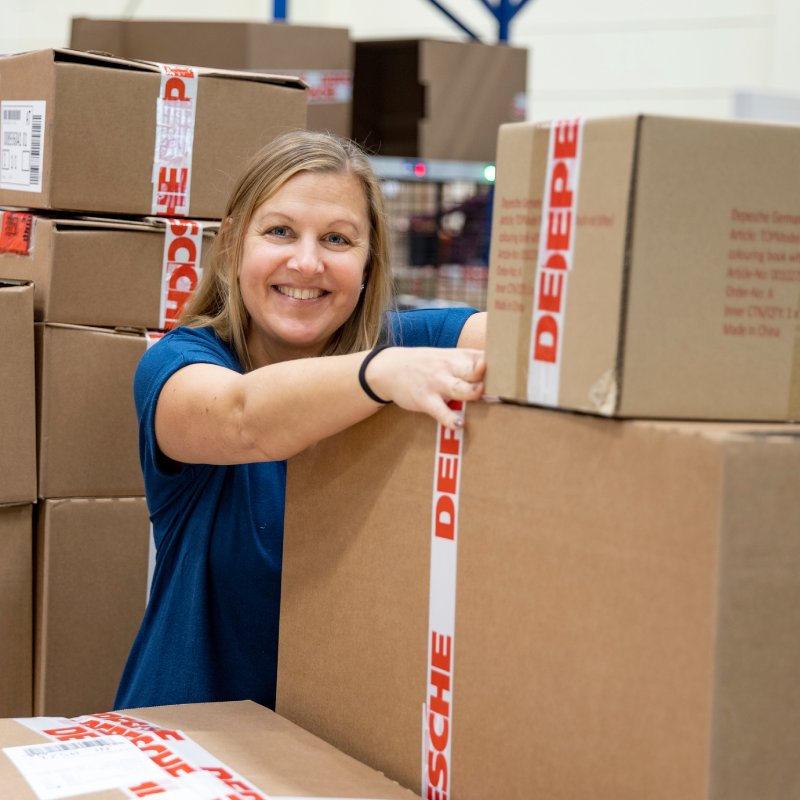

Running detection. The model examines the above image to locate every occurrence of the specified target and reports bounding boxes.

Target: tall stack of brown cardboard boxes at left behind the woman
[0,50,306,715]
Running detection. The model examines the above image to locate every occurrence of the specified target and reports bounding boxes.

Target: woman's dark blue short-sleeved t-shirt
[115,308,474,708]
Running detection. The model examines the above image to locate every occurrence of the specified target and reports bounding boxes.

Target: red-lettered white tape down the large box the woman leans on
[422,401,465,800]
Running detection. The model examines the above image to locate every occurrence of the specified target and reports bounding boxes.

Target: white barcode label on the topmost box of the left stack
[0,100,46,192]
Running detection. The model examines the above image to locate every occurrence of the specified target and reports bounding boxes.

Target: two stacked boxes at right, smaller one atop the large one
[278,116,800,800]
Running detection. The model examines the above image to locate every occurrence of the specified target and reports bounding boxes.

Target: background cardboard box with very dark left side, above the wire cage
[353,39,528,161]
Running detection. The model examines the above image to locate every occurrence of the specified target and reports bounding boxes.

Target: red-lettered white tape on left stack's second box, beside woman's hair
[158,219,203,330]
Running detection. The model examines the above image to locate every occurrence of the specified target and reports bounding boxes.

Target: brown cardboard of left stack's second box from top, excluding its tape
[0,216,216,330]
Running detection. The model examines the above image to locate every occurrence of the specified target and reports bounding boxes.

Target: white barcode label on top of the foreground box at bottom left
[3,736,162,800]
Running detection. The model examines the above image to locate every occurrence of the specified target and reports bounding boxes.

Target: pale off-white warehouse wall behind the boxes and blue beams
[0,0,800,120]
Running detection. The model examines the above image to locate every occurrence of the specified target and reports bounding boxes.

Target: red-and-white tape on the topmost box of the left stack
[152,64,197,217]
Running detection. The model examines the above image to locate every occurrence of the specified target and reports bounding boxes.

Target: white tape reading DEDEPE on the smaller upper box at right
[527,119,583,406]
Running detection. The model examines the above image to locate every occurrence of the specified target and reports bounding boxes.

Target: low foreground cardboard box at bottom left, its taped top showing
[0,700,416,800]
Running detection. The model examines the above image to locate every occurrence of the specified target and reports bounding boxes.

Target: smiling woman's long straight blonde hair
[179,130,392,371]
